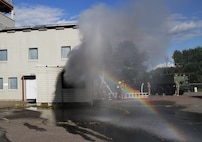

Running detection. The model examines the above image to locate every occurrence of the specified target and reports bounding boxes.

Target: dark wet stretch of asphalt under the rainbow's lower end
[53,96,202,142]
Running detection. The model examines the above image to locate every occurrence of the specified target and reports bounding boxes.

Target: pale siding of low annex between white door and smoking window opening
[36,66,63,103]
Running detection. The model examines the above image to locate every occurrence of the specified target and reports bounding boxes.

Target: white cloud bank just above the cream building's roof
[15,4,76,26]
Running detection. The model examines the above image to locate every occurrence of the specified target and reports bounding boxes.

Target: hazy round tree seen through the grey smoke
[108,41,147,85]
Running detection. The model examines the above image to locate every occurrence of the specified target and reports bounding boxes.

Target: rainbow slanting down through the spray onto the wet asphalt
[103,71,185,141]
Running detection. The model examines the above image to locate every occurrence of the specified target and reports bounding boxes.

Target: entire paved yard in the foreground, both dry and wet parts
[0,93,202,142]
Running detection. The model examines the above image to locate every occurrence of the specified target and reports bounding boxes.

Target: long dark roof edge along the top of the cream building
[0,24,77,32]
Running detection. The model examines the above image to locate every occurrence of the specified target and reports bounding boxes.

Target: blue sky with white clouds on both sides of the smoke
[13,0,202,66]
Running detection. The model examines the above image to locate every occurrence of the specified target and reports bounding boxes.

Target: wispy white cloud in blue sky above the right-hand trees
[167,14,202,42]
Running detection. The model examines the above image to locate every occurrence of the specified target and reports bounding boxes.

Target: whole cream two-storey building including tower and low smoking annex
[0,0,98,104]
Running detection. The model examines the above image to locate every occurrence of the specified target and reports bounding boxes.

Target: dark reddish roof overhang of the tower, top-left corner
[0,0,13,13]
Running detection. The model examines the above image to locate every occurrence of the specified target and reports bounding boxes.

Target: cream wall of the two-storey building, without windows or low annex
[0,27,80,100]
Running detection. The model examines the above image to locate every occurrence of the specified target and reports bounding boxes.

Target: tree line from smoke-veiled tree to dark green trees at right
[102,42,202,85]
